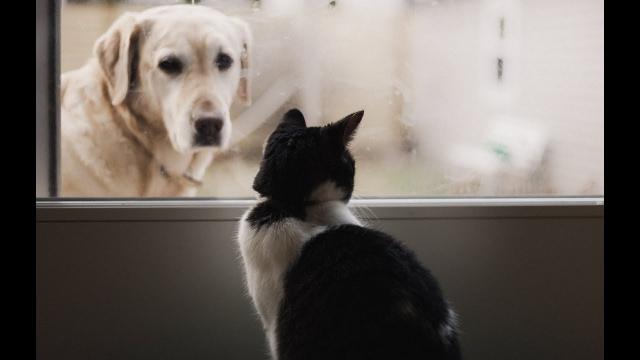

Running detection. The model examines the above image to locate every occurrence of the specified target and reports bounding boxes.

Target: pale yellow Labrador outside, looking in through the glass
[60,5,251,197]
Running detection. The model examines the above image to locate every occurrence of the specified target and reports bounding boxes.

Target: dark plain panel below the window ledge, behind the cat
[36,207,604,360]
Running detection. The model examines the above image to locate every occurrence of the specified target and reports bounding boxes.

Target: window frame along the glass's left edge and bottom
[36,0,604,210]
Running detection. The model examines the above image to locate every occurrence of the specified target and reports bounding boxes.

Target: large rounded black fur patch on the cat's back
[278,225,459,360]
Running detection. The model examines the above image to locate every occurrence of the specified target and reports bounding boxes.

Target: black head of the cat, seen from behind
[253,109,364,206]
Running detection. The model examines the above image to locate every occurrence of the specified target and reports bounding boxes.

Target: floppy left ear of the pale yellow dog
[93,12,139,105]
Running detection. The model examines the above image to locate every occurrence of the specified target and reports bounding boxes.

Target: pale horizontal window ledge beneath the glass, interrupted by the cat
[36,197,604,222]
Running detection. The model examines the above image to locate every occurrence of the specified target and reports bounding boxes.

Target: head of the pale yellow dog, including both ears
[95,5,251,153]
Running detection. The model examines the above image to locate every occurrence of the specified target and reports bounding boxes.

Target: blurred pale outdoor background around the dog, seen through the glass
[60,0,604,198]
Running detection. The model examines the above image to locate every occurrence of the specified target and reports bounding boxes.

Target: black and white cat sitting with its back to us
[238,109,460,360]
